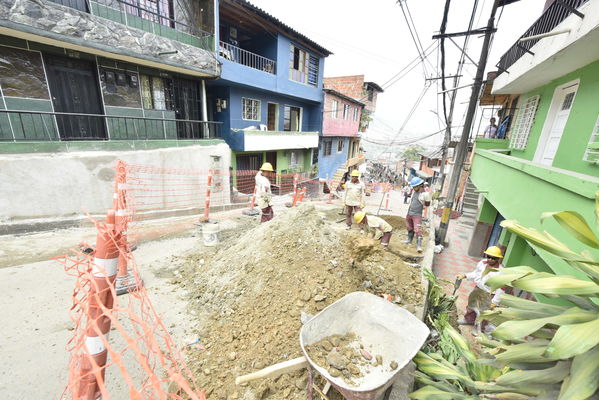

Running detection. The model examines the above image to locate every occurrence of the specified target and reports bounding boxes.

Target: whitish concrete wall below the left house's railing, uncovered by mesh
[0,144,231,223]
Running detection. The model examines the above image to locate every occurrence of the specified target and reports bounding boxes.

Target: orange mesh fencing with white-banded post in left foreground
[58,213,205,400]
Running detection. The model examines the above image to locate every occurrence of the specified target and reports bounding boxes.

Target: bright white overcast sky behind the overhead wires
[250,0,545,157]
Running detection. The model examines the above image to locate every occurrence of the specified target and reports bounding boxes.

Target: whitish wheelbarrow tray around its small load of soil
[300,292,430,400]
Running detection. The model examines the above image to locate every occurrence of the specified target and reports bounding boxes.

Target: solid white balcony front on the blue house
[232,129,318,151]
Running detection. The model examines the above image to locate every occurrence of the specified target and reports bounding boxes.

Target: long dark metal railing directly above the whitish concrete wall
[0,110,222,142]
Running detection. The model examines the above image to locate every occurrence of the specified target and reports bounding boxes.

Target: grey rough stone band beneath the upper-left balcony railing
[0,0,220,77]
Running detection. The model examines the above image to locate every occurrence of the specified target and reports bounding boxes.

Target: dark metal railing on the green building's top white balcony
[496,0,589,74]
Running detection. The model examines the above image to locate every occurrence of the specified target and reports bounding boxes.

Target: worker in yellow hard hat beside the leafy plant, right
[457,246,504,330]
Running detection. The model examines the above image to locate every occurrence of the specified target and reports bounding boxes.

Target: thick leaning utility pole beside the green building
[439,0,503,244]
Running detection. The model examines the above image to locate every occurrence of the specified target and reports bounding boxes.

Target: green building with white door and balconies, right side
[470,0,599,282]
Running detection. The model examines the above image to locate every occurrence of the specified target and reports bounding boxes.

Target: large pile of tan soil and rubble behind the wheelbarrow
[176,205,424,399]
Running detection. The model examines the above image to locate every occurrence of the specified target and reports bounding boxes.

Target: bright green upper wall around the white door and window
[511,61,599,176]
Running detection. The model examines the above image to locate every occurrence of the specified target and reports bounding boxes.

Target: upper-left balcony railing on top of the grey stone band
[90,0,214,51]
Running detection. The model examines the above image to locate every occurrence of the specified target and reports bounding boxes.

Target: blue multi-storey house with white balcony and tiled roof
[207,0,331,181]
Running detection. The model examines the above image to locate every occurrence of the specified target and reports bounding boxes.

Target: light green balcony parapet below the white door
[470,150,599,276]
